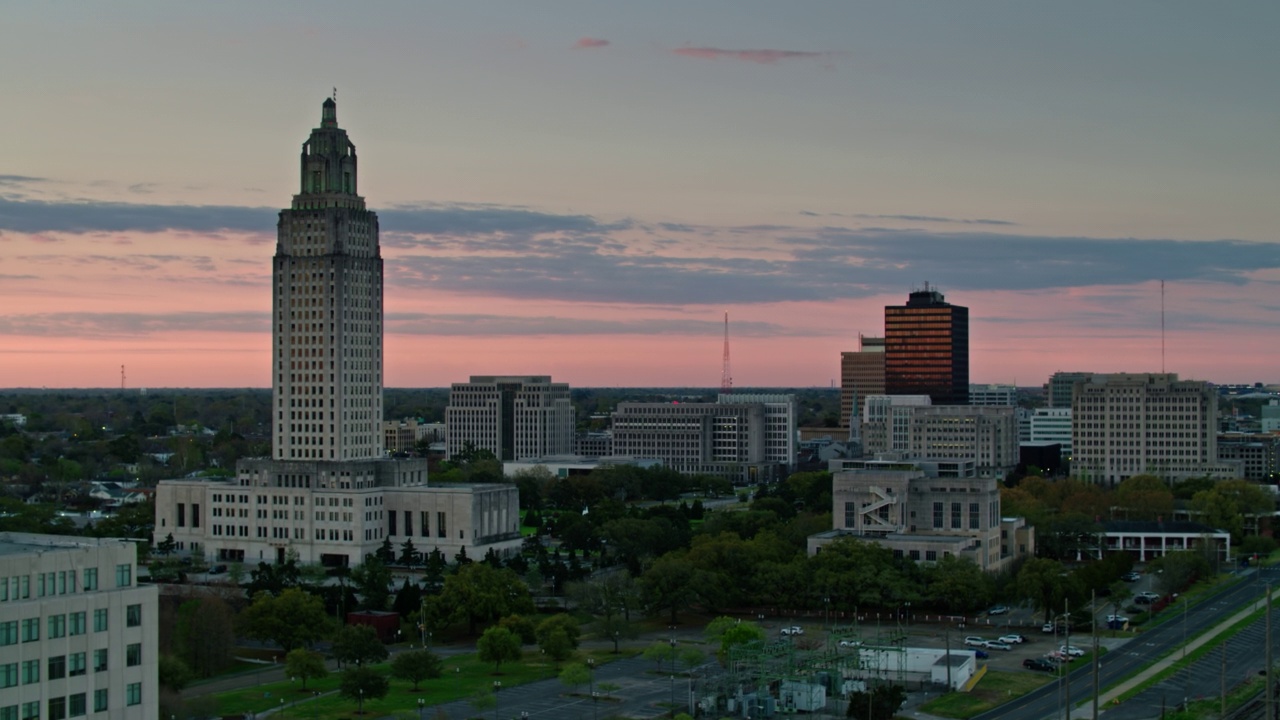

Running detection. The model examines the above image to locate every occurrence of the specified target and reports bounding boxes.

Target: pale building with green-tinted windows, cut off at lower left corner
[0,533,160,720]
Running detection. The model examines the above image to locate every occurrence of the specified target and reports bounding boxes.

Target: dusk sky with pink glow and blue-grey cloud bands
[0,0,1280,388]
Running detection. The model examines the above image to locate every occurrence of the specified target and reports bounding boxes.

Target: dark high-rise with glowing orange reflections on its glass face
[884,284,969,405]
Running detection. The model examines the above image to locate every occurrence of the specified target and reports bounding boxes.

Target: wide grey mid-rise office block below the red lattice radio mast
[613,395,796,484]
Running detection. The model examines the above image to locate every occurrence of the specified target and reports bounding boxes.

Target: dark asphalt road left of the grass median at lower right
[974,569,1280,720]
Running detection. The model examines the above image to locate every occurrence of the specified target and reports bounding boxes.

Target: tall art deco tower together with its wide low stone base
[155,99,520,565]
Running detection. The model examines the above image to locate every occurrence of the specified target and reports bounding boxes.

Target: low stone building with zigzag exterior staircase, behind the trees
[808,460,1034,570]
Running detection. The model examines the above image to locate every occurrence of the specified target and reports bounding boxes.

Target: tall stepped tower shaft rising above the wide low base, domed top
[271,99,383,460]
